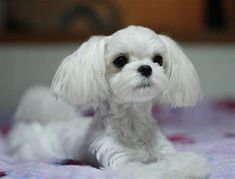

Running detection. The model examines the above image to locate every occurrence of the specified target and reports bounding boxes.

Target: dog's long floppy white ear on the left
[52,36,108,105]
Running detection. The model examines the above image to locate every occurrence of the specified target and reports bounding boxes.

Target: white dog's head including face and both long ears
[52,26,201,106]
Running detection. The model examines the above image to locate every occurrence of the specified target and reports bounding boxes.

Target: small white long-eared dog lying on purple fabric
[9,26,210,179]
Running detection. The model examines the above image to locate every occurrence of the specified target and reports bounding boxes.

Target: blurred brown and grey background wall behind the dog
[0,0,235,113]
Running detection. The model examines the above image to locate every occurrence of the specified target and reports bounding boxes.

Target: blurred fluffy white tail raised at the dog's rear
[14,86,80,124]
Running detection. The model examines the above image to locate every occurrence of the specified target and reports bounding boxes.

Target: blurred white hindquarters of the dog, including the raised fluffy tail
[8,87,92,160]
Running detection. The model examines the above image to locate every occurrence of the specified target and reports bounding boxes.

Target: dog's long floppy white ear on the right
[159,35,202,107]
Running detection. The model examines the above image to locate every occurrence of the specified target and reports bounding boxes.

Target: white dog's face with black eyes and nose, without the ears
[105,27,169,102]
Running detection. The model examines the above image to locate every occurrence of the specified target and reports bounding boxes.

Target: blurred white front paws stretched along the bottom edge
[111,153,210,179]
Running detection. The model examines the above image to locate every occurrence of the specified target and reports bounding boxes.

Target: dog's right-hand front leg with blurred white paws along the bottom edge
[112,129,210,179]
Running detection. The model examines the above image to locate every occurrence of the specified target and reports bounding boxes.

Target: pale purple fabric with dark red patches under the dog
[0,100,235,179]
